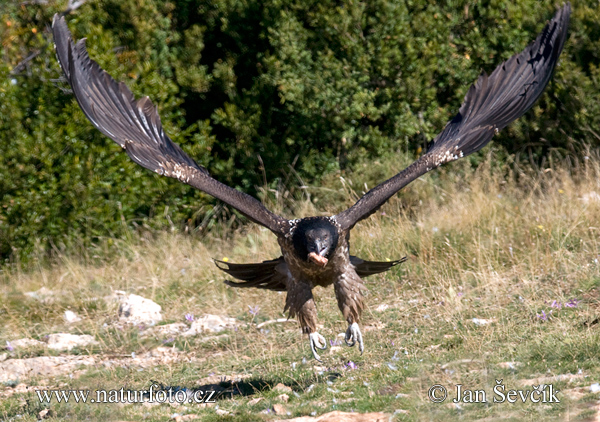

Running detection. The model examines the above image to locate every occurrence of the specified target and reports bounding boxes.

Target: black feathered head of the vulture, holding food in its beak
[292,217,339,267]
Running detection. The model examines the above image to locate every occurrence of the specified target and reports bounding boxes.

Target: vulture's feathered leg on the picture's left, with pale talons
[284,281,327,362]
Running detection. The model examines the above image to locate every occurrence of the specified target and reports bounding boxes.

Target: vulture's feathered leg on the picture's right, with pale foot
[334,273,365,354]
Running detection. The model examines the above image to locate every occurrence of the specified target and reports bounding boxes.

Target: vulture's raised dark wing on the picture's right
[335,3,571,230]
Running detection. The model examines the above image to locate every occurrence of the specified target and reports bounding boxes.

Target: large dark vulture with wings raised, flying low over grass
[52,3,571,360]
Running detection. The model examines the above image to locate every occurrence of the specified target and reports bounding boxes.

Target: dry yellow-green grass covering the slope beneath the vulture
[0,150,600,421]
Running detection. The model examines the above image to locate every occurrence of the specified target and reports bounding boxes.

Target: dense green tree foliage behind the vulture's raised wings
[0,0,600,259]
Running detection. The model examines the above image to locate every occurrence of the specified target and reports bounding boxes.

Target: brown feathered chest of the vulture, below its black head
[279,238,350,287]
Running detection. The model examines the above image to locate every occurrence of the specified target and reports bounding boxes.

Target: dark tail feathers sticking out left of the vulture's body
[214,257,287,292]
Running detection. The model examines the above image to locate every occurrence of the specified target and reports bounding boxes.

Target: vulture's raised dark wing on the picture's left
[52,14,289,234]
